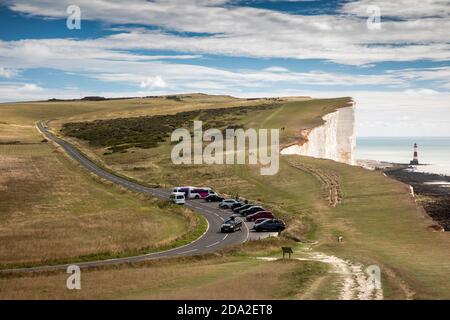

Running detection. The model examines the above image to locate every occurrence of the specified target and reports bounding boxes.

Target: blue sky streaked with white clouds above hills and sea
[0,0,450,136]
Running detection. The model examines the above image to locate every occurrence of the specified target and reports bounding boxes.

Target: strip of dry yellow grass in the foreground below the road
[0,258,326,300]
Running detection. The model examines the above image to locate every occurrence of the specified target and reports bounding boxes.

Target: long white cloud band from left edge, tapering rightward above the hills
[0,35,414,91]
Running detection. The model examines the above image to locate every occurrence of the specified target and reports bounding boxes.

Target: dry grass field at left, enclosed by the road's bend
[0,124,202,267]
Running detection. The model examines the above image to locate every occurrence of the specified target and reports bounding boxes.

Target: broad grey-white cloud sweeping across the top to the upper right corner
[6,0,450,65]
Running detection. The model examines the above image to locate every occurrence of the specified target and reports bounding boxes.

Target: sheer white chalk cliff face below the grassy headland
[280,103,356,165]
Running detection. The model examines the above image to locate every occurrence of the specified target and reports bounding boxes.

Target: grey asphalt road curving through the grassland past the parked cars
[2,121,256,272]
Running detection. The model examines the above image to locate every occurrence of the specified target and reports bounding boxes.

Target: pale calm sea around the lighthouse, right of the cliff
[355,137,450,176]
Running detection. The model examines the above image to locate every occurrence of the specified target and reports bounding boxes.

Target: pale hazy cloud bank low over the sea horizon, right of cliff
[317,89,450,137]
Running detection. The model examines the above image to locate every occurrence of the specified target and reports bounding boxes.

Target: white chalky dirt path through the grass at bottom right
[258,252,383,300]
